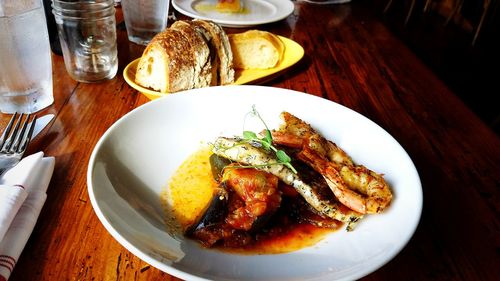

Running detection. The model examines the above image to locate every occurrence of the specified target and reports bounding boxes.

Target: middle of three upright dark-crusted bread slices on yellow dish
[170,20,212,88]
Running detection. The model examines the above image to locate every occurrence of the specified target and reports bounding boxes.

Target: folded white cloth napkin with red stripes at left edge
[0,152,55,281]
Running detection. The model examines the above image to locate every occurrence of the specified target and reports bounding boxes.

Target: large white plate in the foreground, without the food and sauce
[87,86,422,280]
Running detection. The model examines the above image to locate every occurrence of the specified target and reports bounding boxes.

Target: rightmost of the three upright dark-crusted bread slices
[191,20,234,85]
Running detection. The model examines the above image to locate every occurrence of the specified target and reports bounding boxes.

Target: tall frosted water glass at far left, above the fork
[0,0,54,113]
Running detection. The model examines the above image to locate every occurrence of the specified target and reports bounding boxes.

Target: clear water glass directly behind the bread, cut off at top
[121,0,169,45]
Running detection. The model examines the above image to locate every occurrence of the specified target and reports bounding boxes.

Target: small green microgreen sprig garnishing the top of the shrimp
[239,105,297,174]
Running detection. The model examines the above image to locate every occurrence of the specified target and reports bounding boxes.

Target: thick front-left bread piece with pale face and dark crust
[135,29,195,93]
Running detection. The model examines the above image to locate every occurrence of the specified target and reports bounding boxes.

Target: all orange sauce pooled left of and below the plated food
[161,146,342,254]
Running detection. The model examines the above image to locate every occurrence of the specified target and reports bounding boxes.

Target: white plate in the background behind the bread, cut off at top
[172,0,294,28]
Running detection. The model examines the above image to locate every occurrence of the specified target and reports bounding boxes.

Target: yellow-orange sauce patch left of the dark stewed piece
[162,145,217,230]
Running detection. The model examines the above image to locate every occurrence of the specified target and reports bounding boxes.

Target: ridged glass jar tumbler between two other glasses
[52,0,118,82]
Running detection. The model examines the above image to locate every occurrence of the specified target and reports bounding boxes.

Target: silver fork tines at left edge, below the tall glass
[0,113,36,176]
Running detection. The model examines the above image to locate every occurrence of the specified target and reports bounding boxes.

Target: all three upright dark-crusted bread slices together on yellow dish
[135,20,234,93]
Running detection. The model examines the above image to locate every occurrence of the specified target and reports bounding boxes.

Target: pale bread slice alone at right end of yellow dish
[229,30,285,69]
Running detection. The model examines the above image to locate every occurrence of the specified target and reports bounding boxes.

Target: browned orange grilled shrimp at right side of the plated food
[272,112,392,214]
